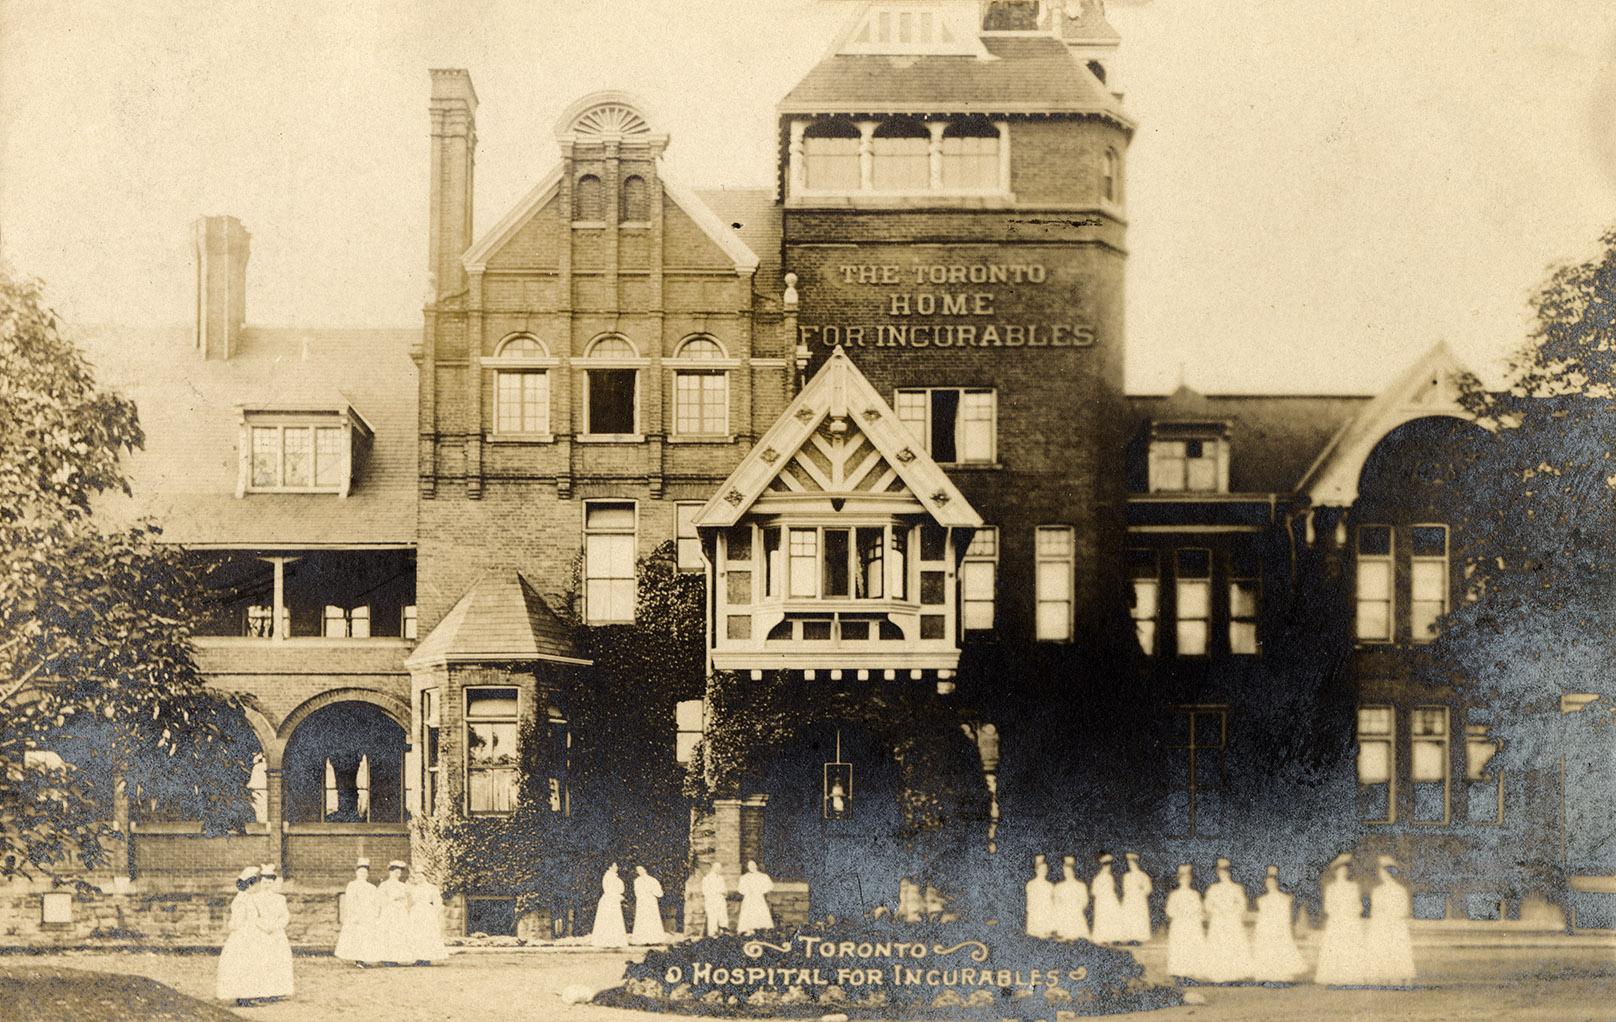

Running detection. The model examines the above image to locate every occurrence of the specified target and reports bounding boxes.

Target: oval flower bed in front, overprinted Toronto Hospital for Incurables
[595,923,1183,1022]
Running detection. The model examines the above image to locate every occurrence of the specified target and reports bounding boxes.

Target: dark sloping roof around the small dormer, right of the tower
[1128,386,1370,495]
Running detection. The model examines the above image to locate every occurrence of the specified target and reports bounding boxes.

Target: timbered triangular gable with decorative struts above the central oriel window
[696,348,983,529]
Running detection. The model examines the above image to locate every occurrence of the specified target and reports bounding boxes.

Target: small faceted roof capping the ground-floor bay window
[404,568,591,668]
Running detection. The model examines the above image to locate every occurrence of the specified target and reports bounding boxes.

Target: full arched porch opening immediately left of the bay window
[283,702,404,823]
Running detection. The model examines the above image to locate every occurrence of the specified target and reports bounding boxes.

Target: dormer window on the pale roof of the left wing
[236,408,372,496]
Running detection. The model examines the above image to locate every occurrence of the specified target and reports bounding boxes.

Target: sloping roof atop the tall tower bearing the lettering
[781,36,1133,120]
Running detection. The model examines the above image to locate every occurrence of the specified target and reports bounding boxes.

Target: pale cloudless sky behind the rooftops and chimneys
[0,0,1616,393]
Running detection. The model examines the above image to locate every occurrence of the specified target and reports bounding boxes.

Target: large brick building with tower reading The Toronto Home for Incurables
[8,0,1610,941]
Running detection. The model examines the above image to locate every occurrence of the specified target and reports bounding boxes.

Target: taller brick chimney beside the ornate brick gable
[427,68,477,301]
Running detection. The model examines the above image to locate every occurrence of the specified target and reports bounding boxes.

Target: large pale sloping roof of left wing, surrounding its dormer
[79,327,420,547]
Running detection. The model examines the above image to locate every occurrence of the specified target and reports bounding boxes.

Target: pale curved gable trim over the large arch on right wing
[1296,341,1474,508]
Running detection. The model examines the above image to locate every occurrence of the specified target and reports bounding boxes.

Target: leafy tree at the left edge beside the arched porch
[0,273,254,876]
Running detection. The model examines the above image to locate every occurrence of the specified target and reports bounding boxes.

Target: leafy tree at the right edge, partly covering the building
[1425,228,1616,889]
